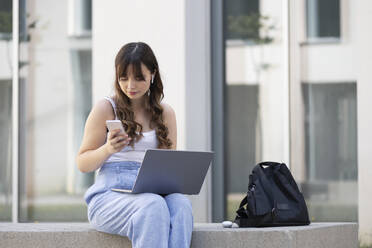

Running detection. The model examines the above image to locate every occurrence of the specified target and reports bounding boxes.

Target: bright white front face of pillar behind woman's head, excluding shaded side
[92,0,185,149]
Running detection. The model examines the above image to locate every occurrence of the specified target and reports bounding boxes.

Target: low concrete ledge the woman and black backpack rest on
[0,223,358,248]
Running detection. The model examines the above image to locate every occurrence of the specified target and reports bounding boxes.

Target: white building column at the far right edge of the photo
[355,0,372,245]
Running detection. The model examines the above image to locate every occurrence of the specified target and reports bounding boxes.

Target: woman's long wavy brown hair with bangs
[114,42,172,149]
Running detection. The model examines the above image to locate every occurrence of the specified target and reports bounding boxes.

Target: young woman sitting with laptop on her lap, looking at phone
[76,42,193,248]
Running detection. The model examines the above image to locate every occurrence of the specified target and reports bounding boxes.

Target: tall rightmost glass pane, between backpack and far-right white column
[290,0,358,221]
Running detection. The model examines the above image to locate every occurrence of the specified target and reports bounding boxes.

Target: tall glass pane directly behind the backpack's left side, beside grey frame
[223,0,288,220]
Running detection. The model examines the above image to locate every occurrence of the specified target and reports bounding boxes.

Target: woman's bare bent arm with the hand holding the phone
[76,99,127,172]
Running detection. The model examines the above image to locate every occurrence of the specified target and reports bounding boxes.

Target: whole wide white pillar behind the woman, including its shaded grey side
[92,0,210,221]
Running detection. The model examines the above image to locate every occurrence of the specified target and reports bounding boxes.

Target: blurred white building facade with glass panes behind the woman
[0,0,372,244]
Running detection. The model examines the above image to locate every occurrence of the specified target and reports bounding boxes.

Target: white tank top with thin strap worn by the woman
[105,97,158,163]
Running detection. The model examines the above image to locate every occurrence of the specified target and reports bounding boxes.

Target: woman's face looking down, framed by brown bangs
[119,63,151,100]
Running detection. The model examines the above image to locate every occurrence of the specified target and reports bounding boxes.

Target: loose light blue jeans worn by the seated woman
[84,161,193,248]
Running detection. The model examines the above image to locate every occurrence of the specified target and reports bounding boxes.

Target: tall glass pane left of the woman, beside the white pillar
[19,0,94,222]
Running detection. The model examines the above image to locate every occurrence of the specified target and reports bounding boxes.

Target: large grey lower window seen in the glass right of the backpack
[298,82,358,221]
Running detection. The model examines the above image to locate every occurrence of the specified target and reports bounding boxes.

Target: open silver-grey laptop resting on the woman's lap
[111,149,214,195]
